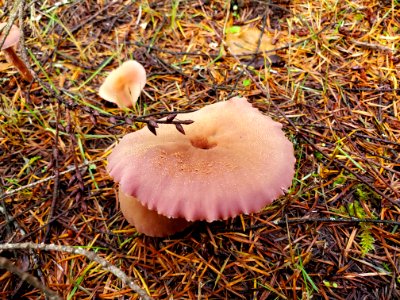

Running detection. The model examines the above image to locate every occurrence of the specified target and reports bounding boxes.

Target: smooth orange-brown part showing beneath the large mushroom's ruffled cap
[119,189,191,237]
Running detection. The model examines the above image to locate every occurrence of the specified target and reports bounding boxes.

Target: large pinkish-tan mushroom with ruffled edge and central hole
[108,97,295,236]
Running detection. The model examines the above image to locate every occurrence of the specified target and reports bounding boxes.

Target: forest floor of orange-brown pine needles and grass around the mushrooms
[0,0,400,299]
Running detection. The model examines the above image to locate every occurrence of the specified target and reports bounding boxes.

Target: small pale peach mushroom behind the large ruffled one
[99,60,146,107]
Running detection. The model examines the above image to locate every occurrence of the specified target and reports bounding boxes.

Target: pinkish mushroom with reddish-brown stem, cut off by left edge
[0,23,33,82]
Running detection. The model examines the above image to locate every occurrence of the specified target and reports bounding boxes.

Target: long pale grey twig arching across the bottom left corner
[0,243,152,300]
